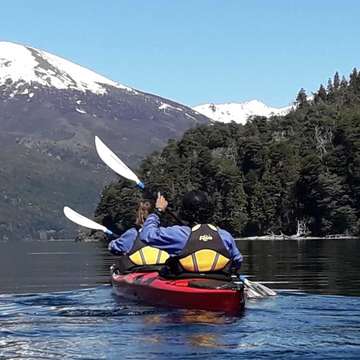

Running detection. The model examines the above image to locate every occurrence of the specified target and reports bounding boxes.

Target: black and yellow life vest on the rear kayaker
[175,224,231,273]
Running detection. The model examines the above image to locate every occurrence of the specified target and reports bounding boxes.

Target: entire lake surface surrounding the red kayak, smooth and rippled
[0,240,360,359]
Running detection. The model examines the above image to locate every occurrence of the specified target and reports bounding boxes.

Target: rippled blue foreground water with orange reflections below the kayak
[0,286,360,359]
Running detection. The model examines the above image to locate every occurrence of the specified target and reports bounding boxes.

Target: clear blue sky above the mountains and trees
[0,0,360,106]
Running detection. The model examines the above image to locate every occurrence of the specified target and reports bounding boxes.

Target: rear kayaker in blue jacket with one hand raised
[140,191,243,274]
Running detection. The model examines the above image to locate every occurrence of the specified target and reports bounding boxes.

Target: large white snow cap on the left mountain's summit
[0,41,136,95]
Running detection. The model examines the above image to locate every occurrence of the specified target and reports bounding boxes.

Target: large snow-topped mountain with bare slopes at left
[0,42,210,240]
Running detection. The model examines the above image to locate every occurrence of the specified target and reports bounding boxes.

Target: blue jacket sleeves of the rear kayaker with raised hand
[140,214,243,267]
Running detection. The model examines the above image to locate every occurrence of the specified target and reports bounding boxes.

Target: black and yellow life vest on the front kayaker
[117,233,169,272]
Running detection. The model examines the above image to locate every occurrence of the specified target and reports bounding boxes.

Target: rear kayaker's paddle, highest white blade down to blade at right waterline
[95,136,276,297]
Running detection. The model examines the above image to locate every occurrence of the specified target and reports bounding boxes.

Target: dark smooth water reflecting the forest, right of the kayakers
[238,239,360,295]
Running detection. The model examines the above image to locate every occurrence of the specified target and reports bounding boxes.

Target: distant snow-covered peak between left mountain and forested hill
[193,100,292,124]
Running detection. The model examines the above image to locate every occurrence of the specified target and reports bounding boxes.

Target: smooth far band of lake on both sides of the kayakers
[0,239,360,295]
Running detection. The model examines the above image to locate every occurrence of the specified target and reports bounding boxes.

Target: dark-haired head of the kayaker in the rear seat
[180,190,214,224]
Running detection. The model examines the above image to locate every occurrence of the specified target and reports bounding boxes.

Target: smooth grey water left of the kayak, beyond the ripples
[0,241,111,293]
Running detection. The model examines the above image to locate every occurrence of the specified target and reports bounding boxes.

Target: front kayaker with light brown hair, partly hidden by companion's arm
[108,201,169,273]
